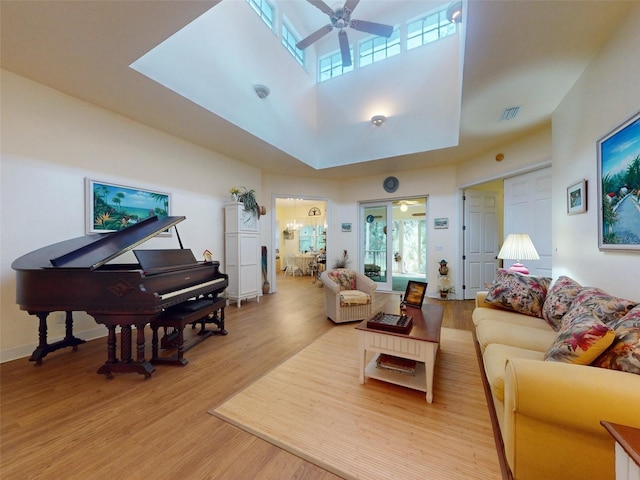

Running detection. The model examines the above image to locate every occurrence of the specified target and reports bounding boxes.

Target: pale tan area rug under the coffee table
[209,325,501,480]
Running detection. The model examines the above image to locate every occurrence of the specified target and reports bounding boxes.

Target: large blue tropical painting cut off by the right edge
[597,112,640,250]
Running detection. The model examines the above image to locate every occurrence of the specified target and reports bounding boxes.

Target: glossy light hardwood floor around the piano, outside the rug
[0,275,473,480]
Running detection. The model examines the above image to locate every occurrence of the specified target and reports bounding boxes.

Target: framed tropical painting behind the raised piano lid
[85,178,171,235]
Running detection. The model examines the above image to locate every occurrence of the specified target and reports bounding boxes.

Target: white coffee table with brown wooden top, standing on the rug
[356,302,444,403]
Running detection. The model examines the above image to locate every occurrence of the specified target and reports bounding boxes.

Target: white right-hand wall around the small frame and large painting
[552,4,640,301]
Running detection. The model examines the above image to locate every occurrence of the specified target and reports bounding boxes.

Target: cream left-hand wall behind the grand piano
[0,70,261,360]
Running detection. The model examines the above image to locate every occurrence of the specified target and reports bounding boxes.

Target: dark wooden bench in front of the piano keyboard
[150,298,227,366]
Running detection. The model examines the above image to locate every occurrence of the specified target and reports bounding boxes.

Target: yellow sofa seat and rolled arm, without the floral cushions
[473,292,640,480]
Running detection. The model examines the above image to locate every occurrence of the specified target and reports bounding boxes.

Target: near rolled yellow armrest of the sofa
[502,358,640,479]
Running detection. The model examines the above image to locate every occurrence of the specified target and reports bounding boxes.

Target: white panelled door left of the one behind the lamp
[463,190,498,300]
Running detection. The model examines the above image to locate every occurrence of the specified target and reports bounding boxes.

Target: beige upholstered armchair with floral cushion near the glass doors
[320,268,378,323]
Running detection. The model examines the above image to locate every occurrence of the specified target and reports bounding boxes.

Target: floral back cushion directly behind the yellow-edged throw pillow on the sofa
[562,287,637,326]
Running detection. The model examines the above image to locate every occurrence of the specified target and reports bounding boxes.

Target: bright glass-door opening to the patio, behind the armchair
[359,197,427,292]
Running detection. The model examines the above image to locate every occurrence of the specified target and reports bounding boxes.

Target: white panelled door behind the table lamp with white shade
[502,167,552,277]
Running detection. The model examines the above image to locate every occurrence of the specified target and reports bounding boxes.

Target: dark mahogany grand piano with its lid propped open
[11,216,229,378]
